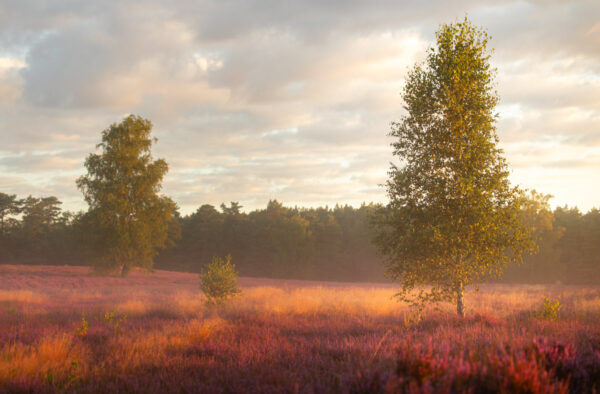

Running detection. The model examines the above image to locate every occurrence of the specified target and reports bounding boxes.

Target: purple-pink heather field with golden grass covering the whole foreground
[0,265,600,393]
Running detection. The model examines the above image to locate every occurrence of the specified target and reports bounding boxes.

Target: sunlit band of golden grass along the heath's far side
[0,284,600,318]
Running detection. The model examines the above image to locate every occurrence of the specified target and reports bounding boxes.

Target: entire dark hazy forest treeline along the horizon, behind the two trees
[0,192,600,284]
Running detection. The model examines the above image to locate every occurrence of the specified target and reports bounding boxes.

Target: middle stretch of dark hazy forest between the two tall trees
[157,201,384,281]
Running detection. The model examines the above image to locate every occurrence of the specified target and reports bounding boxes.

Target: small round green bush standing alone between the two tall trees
[200,255,240,305]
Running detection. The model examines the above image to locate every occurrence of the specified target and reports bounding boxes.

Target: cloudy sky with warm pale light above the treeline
[0,0,600,214]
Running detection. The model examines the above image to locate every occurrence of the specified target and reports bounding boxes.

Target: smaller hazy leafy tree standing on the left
[77,115,177,276]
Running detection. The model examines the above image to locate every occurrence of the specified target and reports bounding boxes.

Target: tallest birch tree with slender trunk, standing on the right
[375,18,534,316]
